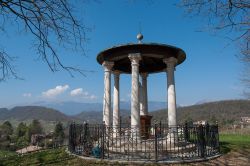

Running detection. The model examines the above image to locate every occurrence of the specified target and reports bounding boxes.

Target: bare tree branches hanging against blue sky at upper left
[0,0,87,80]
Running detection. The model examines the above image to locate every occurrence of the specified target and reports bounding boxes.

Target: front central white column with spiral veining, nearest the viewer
[128,53,141,137]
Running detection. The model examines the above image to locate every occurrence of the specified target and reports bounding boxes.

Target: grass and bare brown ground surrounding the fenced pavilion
[0,134,250,166]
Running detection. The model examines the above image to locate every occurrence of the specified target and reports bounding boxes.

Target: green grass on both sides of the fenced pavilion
[0,134,250,166]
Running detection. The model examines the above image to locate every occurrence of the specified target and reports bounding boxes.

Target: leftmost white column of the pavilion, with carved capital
[102,61,114,126]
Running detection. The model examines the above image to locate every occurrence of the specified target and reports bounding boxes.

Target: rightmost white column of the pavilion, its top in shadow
[163,57,177,127]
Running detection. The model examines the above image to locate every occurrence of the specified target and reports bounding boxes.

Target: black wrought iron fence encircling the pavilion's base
[68,123,219,162]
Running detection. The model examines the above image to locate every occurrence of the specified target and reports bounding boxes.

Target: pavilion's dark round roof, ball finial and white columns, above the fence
[97,34,186,136]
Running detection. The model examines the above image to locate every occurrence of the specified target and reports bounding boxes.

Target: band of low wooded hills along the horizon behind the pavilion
[0,100,250,125]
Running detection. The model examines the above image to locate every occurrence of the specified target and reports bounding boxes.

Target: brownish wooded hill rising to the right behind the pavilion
[150,100,250,125]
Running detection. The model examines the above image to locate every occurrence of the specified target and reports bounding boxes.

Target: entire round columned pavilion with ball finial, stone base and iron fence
[68,34,220,163]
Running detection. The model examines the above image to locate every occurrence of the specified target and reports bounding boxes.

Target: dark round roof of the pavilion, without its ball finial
[97,43,186,73]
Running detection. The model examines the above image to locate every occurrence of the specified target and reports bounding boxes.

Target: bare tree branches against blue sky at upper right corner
[179,0,250,97]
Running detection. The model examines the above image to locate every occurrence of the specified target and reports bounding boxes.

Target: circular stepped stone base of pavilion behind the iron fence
[70,137,218,163]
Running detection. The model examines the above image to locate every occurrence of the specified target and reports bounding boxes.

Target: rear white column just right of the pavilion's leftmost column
[113,71,120,136]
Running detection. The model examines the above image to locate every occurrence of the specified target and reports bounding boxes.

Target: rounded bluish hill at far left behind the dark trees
[0,106,72,121]
